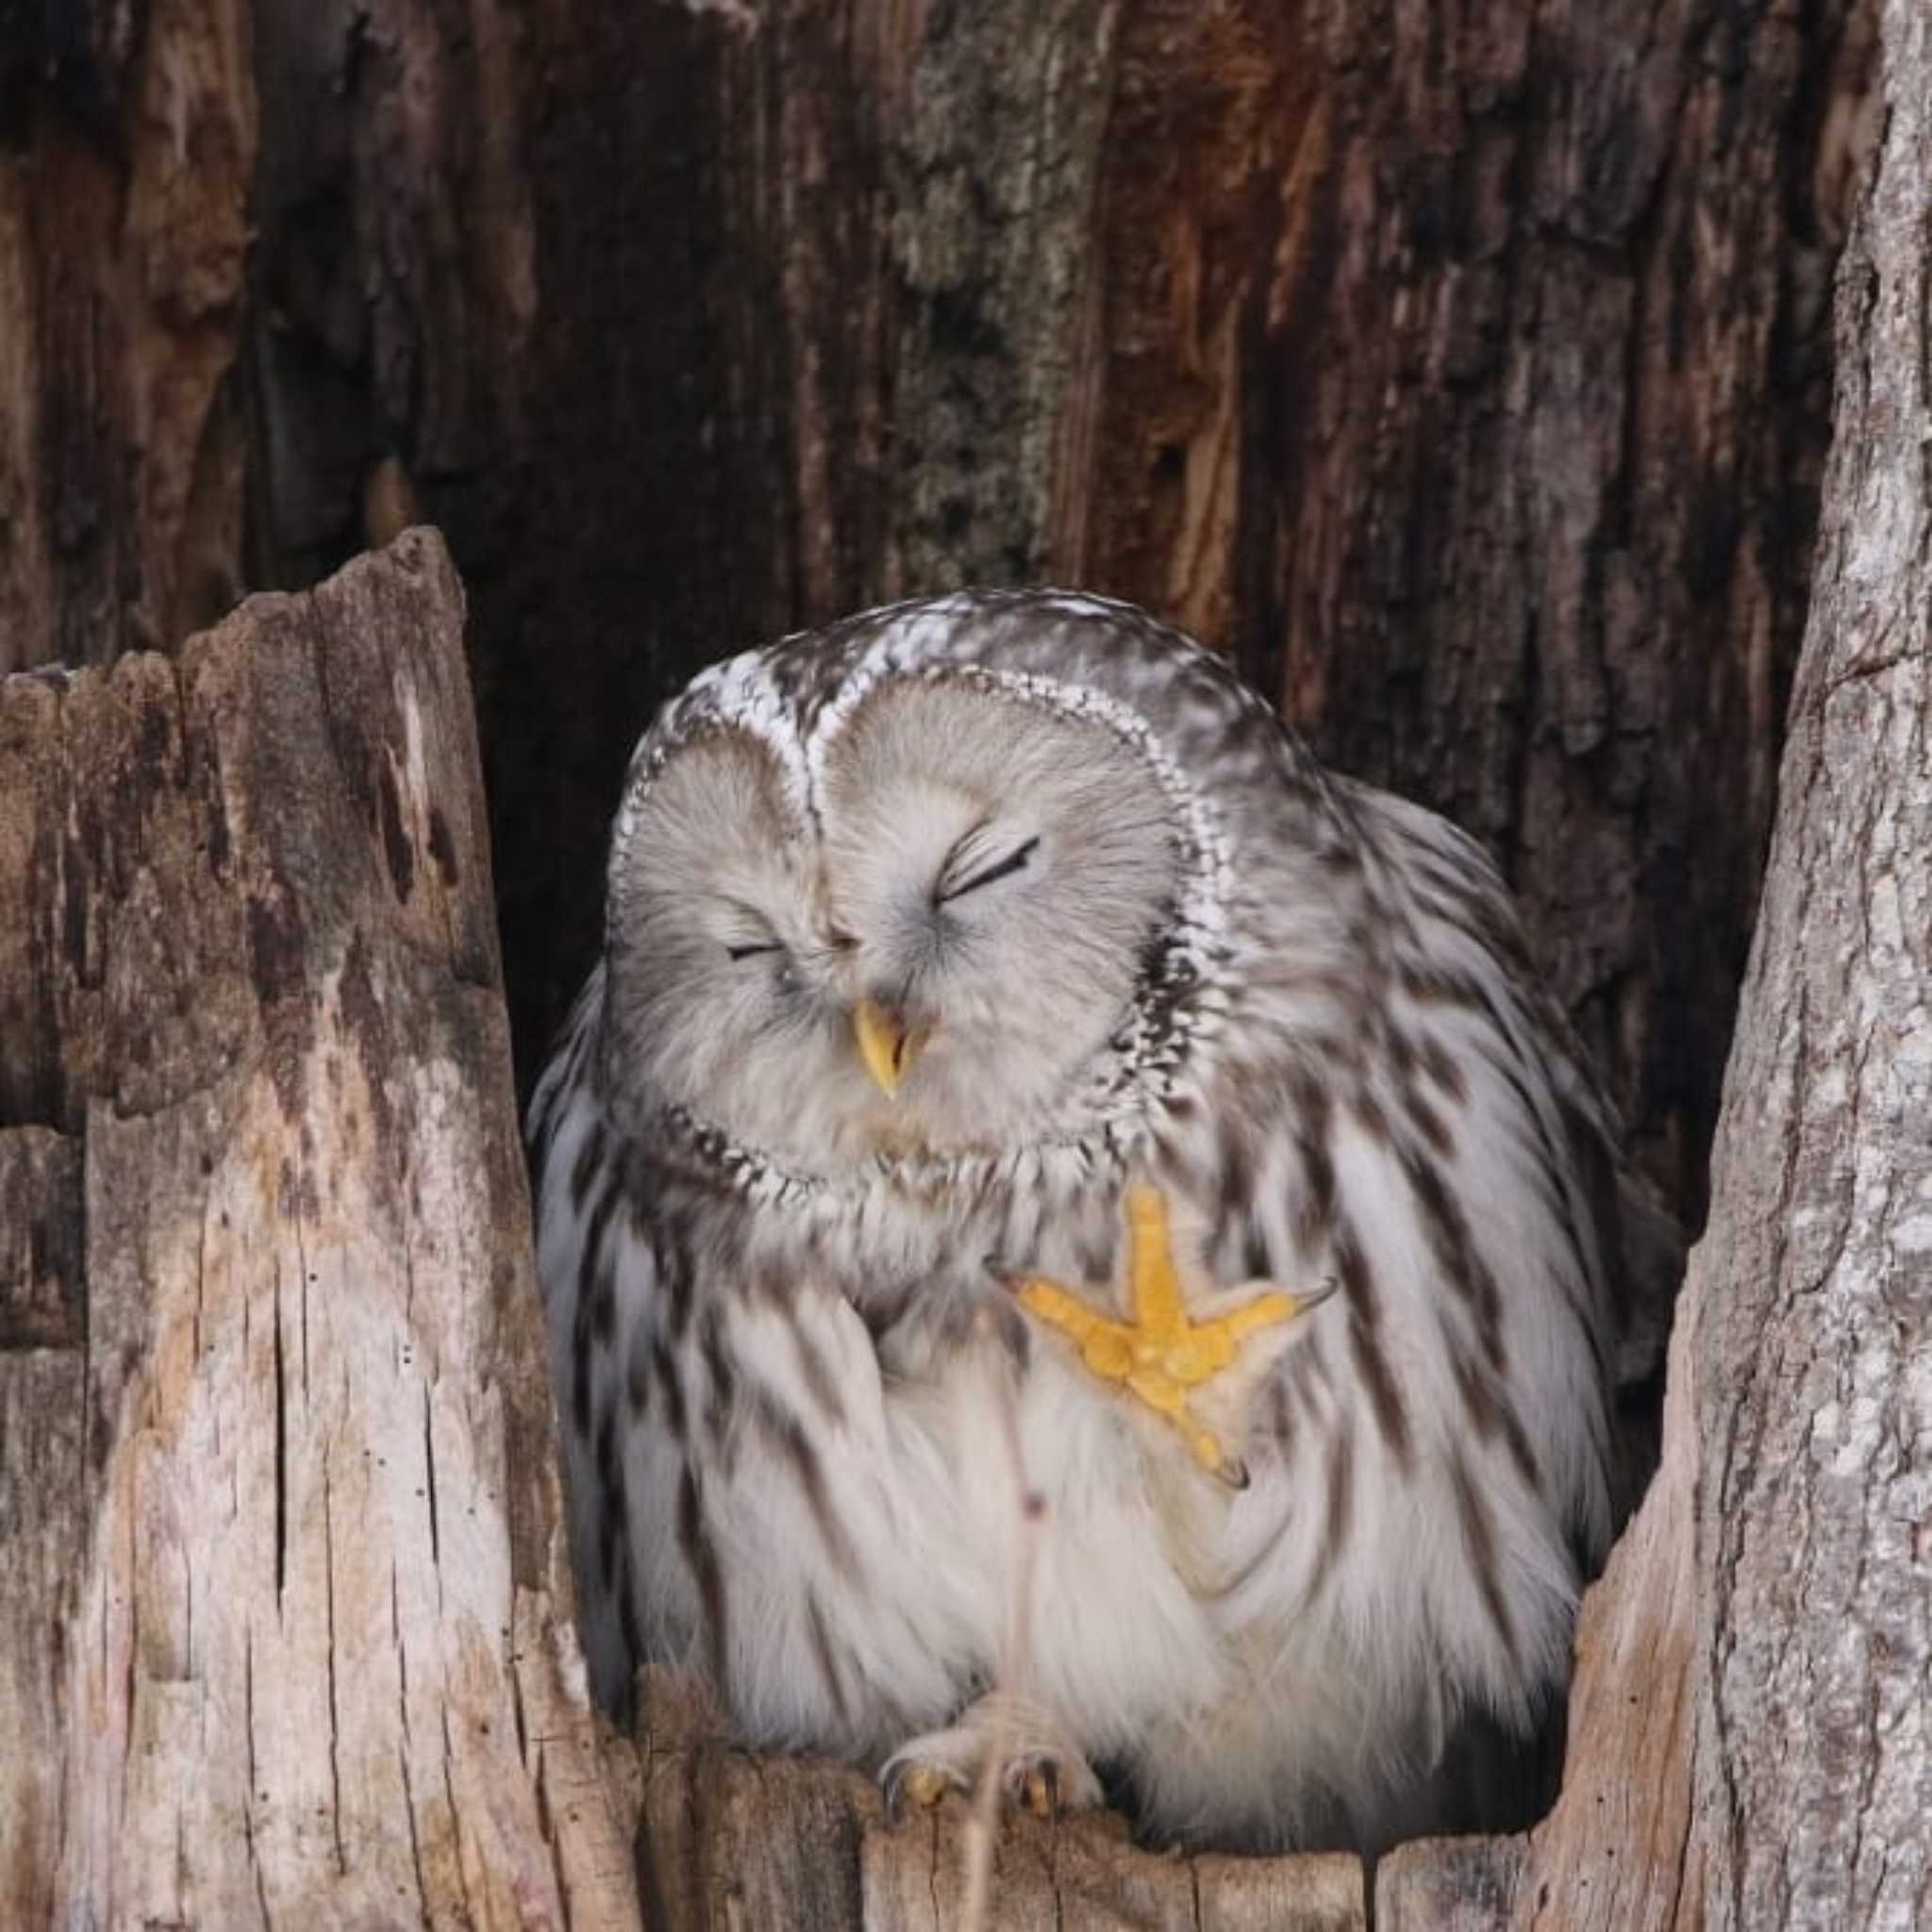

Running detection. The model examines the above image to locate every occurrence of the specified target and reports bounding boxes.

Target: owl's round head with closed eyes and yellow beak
[605,593,1259,1178]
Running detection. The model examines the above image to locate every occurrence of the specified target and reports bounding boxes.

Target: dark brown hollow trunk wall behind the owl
[0,0,1870,1215]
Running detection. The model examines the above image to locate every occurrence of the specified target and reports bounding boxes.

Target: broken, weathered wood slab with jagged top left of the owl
[0,533,634,1926]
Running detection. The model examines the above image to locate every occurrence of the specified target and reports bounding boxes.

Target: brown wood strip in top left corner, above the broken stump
[0,0,258,673]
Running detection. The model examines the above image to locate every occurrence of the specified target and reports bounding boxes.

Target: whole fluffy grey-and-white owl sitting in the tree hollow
[529,591,1645,1849]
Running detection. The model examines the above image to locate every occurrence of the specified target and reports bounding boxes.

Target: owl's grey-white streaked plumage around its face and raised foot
[529,591,1621,1849]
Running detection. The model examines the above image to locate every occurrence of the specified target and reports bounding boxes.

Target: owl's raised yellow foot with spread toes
[1008,1182,1335,1488]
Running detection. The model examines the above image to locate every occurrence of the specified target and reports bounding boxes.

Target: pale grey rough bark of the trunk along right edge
[1696,0,1932,1928]
